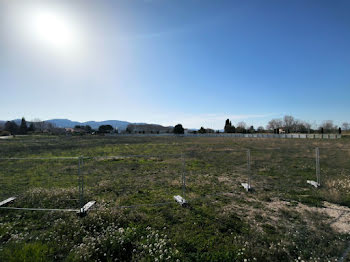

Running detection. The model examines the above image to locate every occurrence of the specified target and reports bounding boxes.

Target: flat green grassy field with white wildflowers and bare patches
[0,136,350,261]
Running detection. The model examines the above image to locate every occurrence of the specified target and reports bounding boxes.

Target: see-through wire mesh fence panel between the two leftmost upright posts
[83,155,184,208]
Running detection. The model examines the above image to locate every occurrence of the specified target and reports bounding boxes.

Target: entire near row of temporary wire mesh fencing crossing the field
[0,147,350,211]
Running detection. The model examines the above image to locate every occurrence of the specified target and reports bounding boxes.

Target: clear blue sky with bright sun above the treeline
[0,0,350,129]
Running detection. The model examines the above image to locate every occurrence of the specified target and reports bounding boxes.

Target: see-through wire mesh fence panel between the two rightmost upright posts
[247,148,317,203]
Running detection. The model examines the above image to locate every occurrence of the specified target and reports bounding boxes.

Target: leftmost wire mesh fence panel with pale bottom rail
[0,157,79,210]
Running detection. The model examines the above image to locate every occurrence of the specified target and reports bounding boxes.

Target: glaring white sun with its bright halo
[6,0,91,69]
